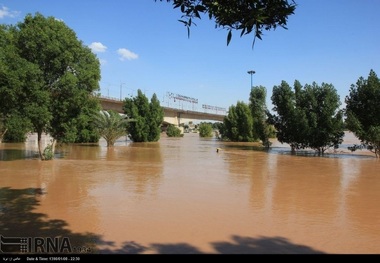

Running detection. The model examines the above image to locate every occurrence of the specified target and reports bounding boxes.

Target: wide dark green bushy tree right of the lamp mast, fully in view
[270,81,344,154]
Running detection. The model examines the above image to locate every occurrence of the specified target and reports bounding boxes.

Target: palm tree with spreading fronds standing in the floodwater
[94,111,133,147]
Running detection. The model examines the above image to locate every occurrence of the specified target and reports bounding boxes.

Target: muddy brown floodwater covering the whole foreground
[0,133,380,254]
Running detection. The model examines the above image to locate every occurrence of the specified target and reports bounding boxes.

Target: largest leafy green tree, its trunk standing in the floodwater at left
[0,13,100,159]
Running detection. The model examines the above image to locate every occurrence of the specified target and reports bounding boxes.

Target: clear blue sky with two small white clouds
[0,0,380,110]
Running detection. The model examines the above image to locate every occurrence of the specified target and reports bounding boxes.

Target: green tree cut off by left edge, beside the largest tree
[0,26,44,144]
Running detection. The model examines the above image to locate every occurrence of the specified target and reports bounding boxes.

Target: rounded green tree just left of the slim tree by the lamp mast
[220,101,254,142]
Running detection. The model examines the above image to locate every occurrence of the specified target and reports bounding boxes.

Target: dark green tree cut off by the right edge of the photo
[345,69,380,157]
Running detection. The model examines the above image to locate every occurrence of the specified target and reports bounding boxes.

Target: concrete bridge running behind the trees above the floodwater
[100,97,225,126]
